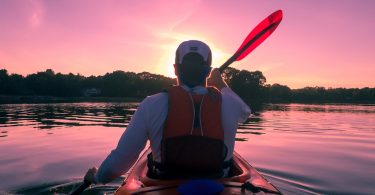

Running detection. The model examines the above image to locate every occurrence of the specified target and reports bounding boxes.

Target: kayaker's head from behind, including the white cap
[174,40,212,87]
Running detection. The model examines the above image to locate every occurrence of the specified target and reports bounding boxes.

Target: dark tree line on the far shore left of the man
[0,69,175,97]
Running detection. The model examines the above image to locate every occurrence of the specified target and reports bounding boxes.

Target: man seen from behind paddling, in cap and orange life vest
[85,40,250,184]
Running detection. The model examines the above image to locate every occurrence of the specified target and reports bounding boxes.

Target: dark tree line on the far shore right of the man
[223,68,375,103]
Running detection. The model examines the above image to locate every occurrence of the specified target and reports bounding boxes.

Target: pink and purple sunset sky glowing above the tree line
[0,0,375,88]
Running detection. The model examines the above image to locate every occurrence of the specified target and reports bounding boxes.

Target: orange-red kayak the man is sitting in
[115,149,282,195]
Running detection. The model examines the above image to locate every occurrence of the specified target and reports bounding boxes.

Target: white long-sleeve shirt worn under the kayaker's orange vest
[95,86,251,183]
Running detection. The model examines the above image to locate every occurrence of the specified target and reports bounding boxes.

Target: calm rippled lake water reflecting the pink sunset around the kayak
[0,103,375,194]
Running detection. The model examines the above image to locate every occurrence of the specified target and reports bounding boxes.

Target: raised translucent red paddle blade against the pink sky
[233,10,283,61]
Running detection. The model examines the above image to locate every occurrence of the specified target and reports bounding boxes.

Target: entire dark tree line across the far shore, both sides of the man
[0,68,375,102]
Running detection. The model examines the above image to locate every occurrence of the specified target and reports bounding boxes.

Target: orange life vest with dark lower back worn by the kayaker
[161,86,227,177]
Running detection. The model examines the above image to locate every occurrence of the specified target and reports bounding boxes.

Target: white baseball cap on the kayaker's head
[175,40,212,66]
